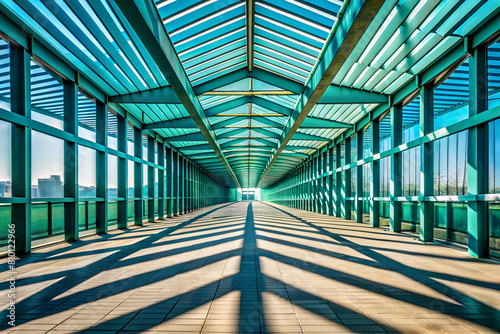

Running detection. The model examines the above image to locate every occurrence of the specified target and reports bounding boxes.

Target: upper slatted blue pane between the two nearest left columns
[31,60,64,130]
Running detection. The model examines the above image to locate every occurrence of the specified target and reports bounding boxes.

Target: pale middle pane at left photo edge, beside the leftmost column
[0,120,12,197]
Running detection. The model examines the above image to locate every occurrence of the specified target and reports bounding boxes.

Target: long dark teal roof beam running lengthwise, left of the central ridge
[111,0,239,187]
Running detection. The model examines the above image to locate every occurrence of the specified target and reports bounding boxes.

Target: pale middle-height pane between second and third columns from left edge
[78,146,96,197]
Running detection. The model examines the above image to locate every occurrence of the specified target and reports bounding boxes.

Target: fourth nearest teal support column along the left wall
[117,116,127,229]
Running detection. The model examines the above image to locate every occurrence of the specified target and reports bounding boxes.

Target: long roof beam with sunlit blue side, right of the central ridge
[258,0,384,185]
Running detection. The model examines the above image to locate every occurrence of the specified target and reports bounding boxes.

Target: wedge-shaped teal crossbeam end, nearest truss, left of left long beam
[109,86,181,104]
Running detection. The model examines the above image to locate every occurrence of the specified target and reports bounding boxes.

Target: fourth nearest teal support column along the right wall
[370,120,380,227]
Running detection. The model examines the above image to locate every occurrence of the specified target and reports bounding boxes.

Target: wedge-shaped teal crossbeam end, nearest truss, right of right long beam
[318,85,389,104]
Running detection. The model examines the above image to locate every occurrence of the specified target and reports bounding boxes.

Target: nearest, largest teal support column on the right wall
[467,45,489,258]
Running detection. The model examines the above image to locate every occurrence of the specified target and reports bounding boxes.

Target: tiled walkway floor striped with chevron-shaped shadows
[0,202,500,333]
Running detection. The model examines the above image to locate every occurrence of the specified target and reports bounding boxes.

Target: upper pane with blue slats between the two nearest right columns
[434,59,469,130]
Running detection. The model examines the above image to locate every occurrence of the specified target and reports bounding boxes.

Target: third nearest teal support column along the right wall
[390,105,403,232]
